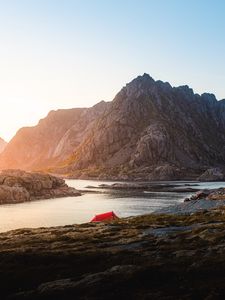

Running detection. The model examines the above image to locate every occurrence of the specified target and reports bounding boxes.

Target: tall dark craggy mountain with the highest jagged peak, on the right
[56,74,225,180]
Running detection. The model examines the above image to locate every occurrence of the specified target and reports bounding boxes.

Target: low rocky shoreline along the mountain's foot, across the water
[62,164,225,183]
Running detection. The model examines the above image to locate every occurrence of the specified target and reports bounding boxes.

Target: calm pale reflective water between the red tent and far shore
[0,180,225,232]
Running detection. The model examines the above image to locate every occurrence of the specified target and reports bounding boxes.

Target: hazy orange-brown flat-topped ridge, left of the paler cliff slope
[0,109,83,169]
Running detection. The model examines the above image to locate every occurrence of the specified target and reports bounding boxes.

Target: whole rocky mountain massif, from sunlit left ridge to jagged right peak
[0,74,225,180]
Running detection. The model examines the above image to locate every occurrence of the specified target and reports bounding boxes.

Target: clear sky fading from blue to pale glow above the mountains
[0,0,225,141]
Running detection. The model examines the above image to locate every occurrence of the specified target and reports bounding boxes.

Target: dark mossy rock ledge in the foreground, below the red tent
[3,208,225,300]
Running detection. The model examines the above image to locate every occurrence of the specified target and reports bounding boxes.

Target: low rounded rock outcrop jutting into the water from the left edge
[0,170,81,204]
